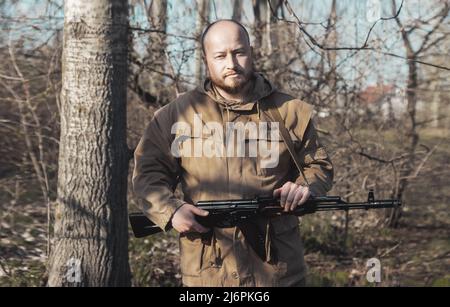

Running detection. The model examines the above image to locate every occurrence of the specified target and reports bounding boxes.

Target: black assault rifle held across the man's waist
[129,191,401,238]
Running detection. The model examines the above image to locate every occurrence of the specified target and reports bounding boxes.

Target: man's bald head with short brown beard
[201,19,253,94]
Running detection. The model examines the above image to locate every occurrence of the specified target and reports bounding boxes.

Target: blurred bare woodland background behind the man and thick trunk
[0,0,450,286]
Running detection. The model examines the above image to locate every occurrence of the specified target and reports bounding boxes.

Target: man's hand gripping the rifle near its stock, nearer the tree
[172,203,209,233]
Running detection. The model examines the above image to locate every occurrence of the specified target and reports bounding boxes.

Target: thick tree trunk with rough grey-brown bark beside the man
[48,0,130,286]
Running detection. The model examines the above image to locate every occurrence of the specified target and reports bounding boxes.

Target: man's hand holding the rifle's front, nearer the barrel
[273,181,311,212]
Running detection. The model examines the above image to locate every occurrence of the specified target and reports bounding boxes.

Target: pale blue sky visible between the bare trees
[0,0,446,89]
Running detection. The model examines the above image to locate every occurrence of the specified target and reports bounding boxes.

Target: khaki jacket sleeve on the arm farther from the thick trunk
[295,119,333,196]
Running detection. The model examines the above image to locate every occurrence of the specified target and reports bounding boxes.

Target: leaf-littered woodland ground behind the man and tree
[0,127,450,286]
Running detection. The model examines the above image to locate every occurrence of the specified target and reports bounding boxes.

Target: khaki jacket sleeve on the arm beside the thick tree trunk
[133,112,185,231]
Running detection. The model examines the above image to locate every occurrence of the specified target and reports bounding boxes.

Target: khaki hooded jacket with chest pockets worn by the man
[133,74,333,286]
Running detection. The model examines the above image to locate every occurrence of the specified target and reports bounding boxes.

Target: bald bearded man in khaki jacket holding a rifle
[133,20,333,286]
